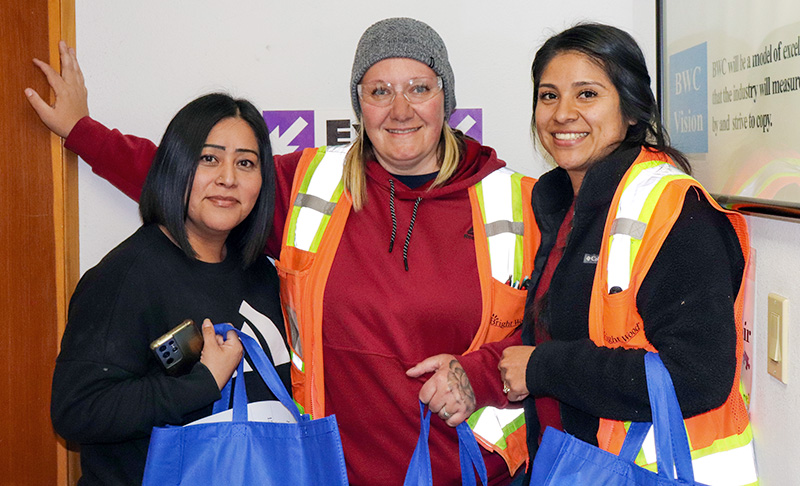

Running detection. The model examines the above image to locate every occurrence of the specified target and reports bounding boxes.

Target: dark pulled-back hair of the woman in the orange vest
[531,23,692,174]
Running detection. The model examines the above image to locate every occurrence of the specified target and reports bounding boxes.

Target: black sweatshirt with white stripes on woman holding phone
[51,225,290,485]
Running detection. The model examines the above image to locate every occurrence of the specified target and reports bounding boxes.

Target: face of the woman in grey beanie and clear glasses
[361,58,444,175]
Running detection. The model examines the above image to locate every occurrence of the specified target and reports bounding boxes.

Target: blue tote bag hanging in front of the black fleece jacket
[530,353,704,486]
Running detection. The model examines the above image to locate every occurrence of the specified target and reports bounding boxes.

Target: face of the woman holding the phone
[186,118,261,261]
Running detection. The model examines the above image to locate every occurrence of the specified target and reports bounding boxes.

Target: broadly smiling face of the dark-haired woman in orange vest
[534,52,631,194]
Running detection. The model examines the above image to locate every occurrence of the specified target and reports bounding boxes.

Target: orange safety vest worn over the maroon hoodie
[276,146,539,474]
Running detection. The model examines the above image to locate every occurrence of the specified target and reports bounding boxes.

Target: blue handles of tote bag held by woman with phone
[212,324,306,423]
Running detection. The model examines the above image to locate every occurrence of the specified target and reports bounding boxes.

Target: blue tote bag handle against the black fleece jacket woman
[619,352,694,484]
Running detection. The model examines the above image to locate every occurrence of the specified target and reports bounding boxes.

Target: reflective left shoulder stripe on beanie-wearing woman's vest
[294,145,350,251]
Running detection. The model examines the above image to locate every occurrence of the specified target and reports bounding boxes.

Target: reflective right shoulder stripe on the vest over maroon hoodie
[481,168,525,282]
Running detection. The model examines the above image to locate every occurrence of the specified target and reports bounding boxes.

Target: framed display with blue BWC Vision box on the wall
[657,0,800,218]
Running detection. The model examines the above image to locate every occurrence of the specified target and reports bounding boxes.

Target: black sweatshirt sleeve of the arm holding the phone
[50,264,220,443]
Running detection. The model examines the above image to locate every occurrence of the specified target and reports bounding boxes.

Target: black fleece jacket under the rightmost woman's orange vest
[523,146,744,459]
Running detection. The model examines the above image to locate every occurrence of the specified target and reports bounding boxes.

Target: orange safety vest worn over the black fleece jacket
[589,149,758,485]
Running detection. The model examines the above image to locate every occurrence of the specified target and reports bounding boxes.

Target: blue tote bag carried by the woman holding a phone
[142,324,347,486]
